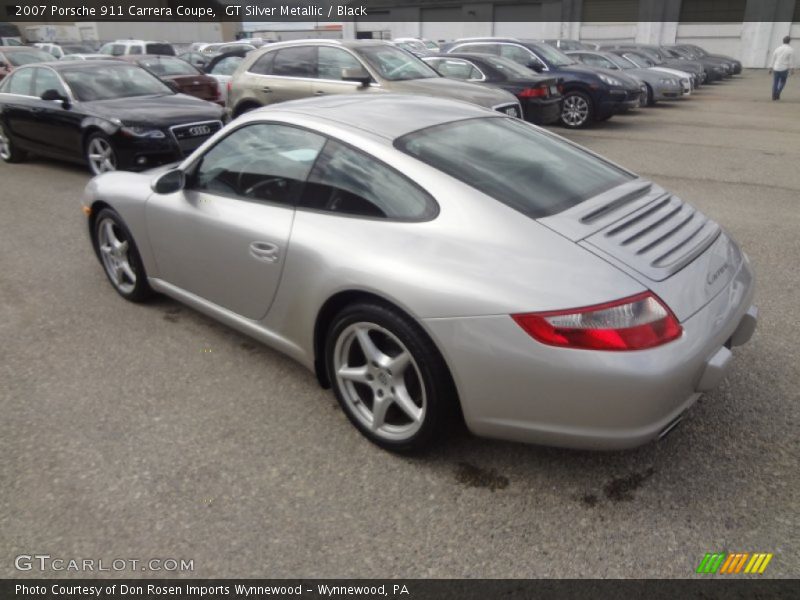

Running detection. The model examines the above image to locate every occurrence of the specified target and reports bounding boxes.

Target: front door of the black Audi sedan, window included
[31,67,83,158]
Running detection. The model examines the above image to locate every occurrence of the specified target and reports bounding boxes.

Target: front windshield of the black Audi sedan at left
[61,64,174,102]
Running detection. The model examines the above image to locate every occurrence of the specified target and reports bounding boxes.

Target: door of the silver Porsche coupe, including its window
[146,123,325,319]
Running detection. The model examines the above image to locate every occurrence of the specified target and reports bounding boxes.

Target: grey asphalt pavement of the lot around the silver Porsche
[0,71,800,578]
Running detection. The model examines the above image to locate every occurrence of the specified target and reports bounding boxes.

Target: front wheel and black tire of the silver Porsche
[92,208,153,302]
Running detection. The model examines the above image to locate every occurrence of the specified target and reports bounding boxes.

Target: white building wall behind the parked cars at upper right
[344,0,800,68]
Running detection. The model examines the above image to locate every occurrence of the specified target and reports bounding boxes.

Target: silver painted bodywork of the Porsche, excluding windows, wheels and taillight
[84,95,755,448]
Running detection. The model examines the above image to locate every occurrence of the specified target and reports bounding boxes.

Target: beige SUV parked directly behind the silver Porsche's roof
[227,40,522,117]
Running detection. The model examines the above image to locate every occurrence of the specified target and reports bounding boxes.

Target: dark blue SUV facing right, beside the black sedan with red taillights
[442,38,642,128]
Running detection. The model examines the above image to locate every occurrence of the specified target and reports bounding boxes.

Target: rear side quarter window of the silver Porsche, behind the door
[300,140,438,221]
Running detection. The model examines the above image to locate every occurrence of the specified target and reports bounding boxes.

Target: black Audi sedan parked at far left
[0,60,224,175]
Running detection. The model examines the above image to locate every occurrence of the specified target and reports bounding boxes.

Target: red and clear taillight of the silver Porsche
[511,292,683,350]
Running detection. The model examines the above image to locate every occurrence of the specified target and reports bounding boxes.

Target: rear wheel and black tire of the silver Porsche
[325,302,458,453]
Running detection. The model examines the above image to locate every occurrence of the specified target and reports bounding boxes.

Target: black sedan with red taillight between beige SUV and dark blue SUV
[422,53,562,125]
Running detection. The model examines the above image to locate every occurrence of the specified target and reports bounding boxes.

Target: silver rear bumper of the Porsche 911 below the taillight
[425,255,757,449]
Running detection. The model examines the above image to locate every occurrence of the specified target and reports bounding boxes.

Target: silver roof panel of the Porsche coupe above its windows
[250,94,503,140]
